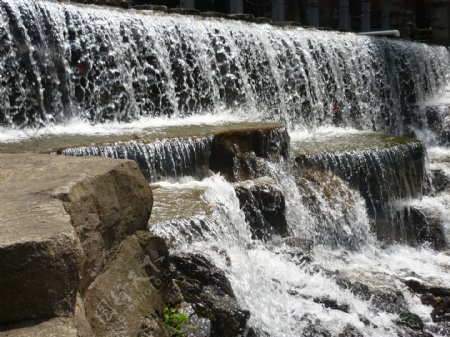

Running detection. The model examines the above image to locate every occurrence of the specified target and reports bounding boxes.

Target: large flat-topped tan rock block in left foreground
[0,154,152,324]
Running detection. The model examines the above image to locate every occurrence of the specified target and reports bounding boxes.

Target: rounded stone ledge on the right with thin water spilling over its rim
[291,132,426,244]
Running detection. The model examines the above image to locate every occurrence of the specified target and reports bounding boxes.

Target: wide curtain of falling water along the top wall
[0,0,450,134]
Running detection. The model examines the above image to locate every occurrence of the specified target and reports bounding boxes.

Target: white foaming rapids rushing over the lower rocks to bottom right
[153,171,450,337]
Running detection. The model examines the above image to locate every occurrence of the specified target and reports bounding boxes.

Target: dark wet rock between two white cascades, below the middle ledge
[235,178,288,241]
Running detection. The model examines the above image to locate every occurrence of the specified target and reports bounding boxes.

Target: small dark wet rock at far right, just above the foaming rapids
[405,207,447,250]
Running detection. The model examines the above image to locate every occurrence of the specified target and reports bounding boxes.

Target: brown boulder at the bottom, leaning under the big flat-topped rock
[85,231,170,337]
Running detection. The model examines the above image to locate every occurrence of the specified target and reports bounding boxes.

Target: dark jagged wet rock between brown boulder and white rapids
[166,254,250,337]
